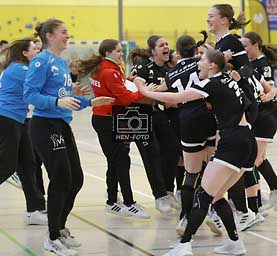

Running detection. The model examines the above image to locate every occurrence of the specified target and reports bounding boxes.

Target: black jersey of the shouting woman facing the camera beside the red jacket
[133,59,168,84]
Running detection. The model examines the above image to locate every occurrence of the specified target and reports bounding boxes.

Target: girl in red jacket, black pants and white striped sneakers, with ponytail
[76,39,150,218]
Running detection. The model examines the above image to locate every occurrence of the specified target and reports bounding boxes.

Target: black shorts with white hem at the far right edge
[253,102,277,142]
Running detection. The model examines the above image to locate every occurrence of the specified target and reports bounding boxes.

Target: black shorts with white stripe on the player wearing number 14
[179,102,216,153]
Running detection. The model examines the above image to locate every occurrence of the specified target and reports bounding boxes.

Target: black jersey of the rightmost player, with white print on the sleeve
[250,55,274,84]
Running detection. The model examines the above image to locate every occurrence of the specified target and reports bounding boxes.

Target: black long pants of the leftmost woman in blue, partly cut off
[0,116,45,212]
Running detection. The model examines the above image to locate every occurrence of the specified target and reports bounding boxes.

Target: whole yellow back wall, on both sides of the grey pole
[0,0,272,48]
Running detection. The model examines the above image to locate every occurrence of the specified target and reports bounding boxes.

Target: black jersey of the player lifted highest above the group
[215,33,250,70]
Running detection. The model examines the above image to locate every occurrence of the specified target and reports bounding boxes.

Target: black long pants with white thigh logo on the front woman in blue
[30,116,84,240]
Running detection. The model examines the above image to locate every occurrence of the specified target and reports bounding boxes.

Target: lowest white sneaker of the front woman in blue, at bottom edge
[44,237,78,256]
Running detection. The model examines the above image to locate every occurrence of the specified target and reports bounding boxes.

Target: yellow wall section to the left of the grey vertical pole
[0,6,117,41]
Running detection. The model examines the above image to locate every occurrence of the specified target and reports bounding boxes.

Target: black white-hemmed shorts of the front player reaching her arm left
[212,126,257,172]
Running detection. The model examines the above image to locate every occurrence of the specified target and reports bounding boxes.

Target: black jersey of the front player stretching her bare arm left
[192,73,249,129]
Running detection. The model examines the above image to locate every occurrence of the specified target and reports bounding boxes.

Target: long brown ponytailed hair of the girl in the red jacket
[77,39,119,76]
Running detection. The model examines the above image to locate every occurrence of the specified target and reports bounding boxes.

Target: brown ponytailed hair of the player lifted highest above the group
[212,4,251,30]
